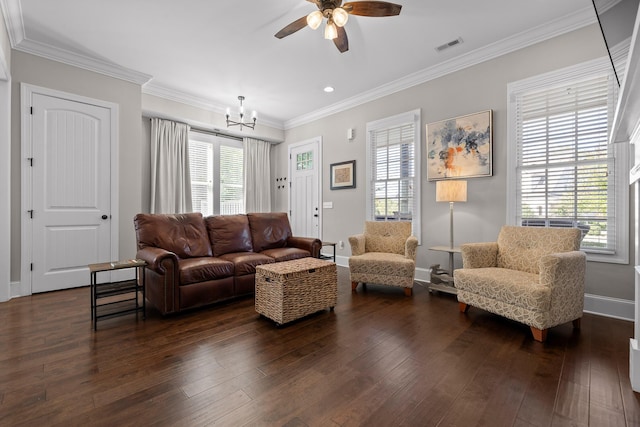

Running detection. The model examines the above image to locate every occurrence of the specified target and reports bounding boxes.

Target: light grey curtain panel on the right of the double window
[243,138,271,212]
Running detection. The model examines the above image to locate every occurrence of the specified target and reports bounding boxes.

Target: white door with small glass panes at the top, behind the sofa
[289,140,322,238]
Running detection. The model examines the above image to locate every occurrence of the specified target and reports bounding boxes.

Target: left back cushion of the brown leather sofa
[133,213,211,258]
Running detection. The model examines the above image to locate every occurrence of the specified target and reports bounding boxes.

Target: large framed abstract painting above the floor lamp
[426,110,493,181]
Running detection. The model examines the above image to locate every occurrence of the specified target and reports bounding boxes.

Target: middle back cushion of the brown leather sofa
[204,215,253,257]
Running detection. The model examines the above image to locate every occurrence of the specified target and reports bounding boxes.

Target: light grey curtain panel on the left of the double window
[150,118,192,213]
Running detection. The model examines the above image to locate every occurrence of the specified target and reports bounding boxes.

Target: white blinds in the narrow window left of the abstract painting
[370,124,416,221]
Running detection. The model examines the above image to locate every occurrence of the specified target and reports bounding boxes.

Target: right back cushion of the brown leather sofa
[247,212,291,252]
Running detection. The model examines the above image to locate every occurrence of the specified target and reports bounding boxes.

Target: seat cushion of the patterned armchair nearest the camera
[454,267,551,312]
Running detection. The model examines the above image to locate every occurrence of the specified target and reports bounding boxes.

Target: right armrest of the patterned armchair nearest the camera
[540,251,587,325]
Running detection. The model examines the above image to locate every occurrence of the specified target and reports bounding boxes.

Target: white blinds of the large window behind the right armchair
[516,75,616,253]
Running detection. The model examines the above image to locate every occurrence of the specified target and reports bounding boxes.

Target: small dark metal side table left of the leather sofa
[89,259,147,330]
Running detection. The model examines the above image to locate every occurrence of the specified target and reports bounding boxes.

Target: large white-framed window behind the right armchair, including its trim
[508,60,628,263]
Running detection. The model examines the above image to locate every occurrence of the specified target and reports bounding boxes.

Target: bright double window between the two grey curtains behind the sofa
[189,131,244,216]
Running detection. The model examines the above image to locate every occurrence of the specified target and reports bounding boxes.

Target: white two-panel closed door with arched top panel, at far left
[31,93,111,293]
